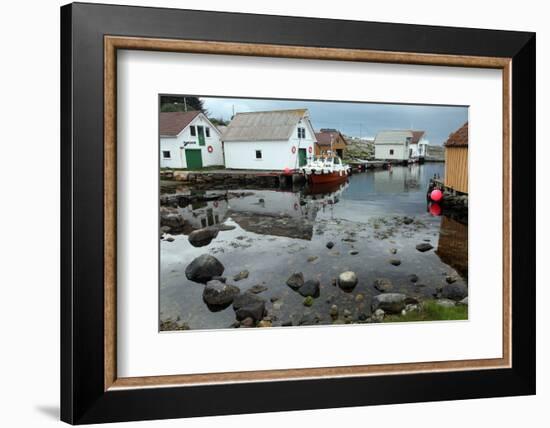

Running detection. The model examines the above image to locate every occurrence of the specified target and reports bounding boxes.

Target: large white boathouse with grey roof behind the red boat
[222,109,316,171]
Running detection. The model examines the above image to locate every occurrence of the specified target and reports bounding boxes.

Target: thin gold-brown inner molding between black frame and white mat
[104,36,512,391]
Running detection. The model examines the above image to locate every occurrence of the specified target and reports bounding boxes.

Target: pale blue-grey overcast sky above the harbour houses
[201,97,468,145]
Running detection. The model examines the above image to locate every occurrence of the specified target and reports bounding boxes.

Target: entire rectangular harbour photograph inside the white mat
[158,94,468,332]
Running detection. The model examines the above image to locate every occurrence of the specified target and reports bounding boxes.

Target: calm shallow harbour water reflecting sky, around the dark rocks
[160,163,467,329]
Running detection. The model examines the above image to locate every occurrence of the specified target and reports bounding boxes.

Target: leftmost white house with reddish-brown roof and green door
[159,111,223,169]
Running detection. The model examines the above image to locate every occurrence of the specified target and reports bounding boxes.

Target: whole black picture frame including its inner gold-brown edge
[61,3,536,424]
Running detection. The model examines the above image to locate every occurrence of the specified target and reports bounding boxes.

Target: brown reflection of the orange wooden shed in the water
[436,216,468,278]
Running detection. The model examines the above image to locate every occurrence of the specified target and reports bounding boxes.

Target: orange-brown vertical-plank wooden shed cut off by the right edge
[445,122,468,193]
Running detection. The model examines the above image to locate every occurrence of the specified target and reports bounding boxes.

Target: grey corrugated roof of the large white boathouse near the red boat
[222,109,307,141]
